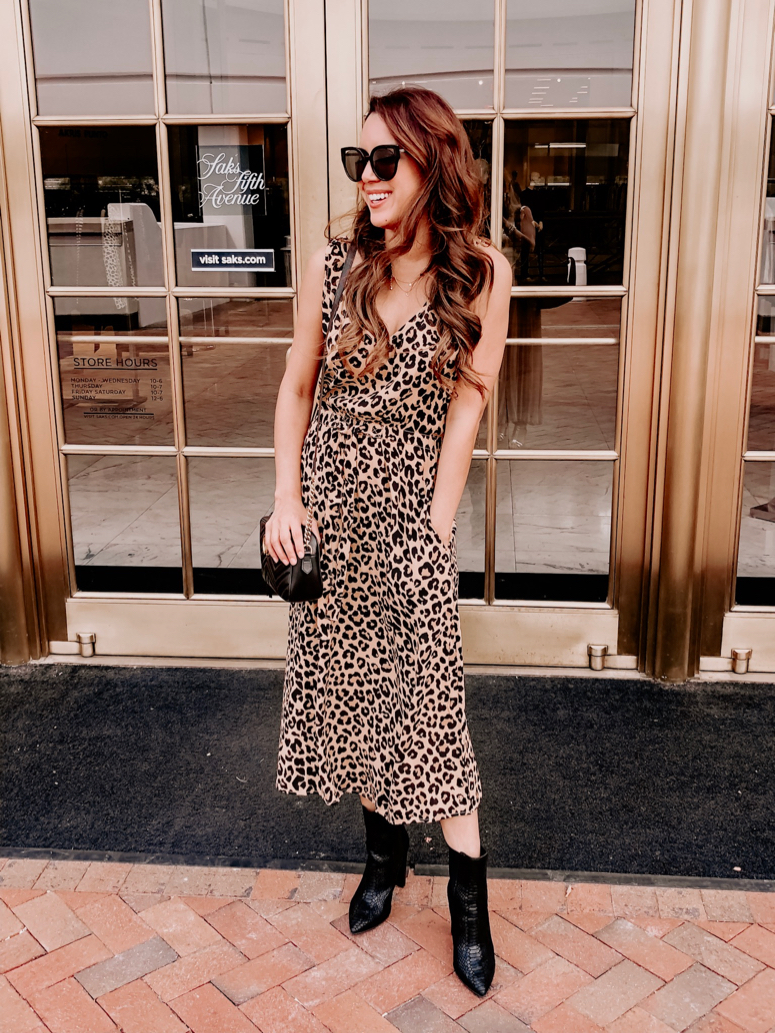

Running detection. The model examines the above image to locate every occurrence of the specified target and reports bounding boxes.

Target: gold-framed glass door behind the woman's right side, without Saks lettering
[330,0,671,666]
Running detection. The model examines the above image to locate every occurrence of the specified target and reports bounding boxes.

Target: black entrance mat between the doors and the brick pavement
[0,665,775,879]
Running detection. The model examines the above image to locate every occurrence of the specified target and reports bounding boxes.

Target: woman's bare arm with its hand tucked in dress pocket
[431,248,513,541]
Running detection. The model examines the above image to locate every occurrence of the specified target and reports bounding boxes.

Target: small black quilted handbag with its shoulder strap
[258,239,355,602]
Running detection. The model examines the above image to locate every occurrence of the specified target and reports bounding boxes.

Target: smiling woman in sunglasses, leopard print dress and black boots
[267,87,512,995]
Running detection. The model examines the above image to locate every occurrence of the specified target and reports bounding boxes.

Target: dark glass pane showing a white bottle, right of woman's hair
[502,119,629,286]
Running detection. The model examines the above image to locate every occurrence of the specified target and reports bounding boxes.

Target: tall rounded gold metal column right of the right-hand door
[653,0,732,681]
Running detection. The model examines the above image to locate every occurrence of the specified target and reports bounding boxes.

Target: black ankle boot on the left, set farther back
[350,804,409,933]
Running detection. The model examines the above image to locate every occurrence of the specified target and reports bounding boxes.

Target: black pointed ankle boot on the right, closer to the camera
[446,847,495,997]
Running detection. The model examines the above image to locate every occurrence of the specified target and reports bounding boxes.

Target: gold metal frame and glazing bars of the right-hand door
[327,0,680,668]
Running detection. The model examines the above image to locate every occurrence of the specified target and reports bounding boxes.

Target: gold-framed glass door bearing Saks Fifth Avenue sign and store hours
[9,0,328,656]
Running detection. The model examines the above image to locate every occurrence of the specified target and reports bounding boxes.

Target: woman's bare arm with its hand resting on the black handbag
[267,245,326,563]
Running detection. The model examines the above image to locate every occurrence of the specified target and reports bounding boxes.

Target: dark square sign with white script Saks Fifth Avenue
[196,144,267,215]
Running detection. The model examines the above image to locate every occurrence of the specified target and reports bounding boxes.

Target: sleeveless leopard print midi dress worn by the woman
[276,240,482,823]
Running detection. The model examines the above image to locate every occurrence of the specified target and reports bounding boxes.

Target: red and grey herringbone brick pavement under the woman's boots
[0,858,775,1033]
